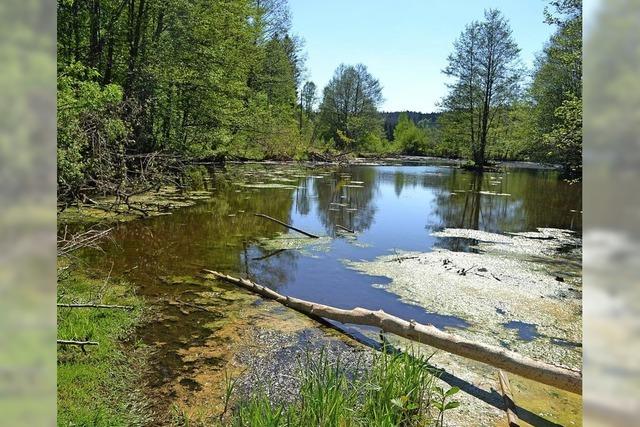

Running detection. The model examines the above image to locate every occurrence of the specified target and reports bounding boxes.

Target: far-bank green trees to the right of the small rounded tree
[384,0,582,176]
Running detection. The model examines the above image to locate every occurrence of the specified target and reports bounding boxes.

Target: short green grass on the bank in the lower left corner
[57,269,144,426]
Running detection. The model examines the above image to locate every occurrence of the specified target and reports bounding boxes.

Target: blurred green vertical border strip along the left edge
[0,0,56,426]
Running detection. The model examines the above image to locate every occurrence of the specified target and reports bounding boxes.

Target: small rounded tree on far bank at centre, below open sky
[320,64,383,148]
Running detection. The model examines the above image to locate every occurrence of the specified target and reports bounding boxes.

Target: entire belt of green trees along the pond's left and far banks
[57,0,582,204]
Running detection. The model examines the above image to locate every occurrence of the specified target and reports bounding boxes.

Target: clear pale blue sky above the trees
[289,0,553,112]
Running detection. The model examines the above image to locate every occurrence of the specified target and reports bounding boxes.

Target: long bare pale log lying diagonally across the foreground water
[203,269,582,394]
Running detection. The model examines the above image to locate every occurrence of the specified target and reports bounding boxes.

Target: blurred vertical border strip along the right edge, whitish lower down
[583,0,640,426]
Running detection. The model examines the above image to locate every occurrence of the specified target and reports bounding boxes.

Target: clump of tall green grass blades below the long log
[229,352,458,427]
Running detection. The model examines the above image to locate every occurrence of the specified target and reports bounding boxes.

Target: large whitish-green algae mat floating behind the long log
[345,230,582,368]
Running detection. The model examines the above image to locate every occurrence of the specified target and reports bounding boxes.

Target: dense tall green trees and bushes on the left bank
[58,0,304,200]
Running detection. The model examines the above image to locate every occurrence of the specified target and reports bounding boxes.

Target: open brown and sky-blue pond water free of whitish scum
[74,165,582,418]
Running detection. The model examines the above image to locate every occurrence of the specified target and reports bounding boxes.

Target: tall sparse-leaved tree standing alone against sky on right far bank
[442,9,521,168]
